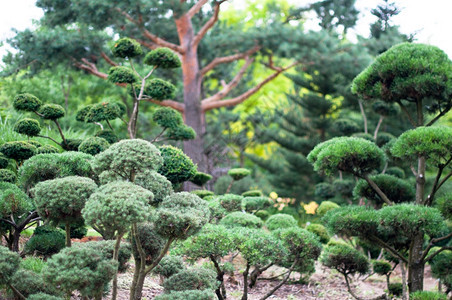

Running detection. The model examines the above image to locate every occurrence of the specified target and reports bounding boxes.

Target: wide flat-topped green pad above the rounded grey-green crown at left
[19,152,94,193]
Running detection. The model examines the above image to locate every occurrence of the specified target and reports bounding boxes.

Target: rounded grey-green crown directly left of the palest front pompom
[32,176,97,223]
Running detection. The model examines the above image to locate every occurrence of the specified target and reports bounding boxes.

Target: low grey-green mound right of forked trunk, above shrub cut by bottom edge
[163,268,219,293]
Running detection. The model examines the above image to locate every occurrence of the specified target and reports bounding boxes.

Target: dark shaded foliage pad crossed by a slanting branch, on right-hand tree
[353,174,416,206]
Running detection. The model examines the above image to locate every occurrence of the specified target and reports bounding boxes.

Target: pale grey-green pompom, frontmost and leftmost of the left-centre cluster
[82,180,154,234]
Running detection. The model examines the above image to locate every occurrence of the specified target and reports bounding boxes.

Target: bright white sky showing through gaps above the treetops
[0,0,452,58]
